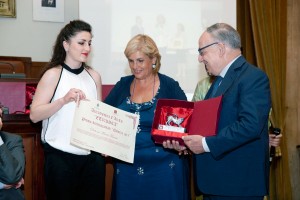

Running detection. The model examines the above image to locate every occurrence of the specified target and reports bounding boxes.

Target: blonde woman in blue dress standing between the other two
[105,34,190,200]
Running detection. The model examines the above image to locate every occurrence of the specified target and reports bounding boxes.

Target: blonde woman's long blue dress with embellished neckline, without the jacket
[112,92,190,200]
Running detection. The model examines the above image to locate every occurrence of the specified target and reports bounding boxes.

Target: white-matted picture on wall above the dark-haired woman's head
[32,0,65,22]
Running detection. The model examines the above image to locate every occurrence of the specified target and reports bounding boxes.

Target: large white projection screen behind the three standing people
[79,0,236,95]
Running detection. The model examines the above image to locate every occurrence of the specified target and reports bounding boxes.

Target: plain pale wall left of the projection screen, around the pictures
[0,0,79,62]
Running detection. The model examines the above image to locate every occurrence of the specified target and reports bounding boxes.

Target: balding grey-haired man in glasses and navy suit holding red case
[164,23,271,200]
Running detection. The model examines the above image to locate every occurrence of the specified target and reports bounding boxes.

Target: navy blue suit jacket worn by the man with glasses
[194,56,271,196]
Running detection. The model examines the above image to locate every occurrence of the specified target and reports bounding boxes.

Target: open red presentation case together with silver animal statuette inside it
[152,96,222,145]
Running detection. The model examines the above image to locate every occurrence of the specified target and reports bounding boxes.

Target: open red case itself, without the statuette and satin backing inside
[151,96,222,145]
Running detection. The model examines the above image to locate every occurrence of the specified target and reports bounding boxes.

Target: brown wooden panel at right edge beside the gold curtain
[283,0,300,200]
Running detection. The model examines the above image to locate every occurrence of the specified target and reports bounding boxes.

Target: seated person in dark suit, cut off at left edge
[0,108,25,200]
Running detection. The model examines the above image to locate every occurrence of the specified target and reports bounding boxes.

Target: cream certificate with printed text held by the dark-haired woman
[71,100,139,163]
